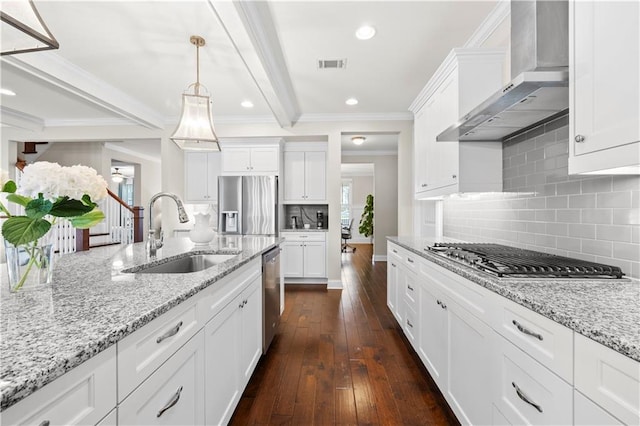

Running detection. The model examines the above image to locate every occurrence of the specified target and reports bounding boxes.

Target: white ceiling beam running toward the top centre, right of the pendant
[209,0,300,127]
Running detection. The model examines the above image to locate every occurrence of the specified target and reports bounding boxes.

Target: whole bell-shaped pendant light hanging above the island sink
[171,36,220,151]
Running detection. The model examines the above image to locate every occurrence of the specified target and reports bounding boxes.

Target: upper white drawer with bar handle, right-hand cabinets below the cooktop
[492,296,573,383]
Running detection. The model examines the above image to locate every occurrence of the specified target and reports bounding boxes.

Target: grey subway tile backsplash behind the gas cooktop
[444,116,640,278]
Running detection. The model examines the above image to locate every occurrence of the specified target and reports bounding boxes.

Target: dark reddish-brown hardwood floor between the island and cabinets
[231,244,458,425]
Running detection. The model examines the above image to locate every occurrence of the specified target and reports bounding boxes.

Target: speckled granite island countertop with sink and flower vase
[0,236,281,411]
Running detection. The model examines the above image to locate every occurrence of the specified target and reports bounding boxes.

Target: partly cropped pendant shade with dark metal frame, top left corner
[0,0,59,56]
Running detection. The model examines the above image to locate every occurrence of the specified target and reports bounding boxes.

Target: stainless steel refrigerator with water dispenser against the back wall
[218,176,278,235]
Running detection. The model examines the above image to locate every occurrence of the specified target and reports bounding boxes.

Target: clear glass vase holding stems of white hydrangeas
[4,232,53,292]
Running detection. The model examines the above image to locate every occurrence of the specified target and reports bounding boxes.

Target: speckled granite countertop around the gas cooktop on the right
[387,237,640,362]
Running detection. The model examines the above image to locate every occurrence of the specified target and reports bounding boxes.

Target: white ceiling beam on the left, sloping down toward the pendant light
[2,52,164,129]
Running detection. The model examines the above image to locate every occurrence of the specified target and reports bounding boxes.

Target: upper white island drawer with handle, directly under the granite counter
[118,298,202,401]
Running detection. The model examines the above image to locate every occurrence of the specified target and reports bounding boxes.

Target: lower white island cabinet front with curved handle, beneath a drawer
[118,331,205,425]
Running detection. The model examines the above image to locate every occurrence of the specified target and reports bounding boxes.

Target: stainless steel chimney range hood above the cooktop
[436,0,569,142]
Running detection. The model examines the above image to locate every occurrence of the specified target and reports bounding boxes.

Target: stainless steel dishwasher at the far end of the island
[262,247,282,354]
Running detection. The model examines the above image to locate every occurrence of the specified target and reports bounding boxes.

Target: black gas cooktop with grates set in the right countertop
[429,243,624,278]
